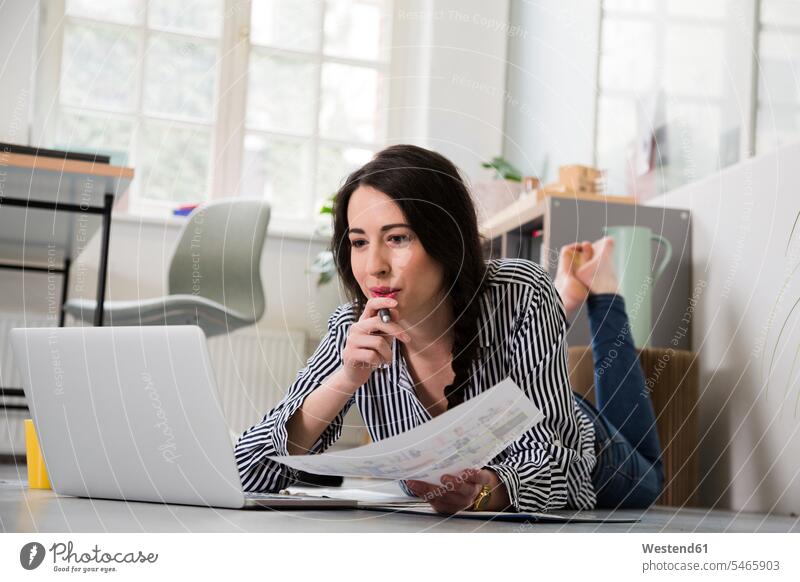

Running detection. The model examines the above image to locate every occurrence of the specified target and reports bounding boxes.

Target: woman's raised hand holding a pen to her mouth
[342,297,411,387]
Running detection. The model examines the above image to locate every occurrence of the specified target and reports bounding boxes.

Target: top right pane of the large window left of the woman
[325,0,386,60]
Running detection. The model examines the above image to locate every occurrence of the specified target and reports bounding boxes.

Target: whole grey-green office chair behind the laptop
[64,198,270,337]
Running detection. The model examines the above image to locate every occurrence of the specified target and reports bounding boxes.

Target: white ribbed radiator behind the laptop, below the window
[0,313,310,455]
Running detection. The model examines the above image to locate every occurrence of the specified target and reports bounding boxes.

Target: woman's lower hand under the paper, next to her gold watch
[406,469,509,515]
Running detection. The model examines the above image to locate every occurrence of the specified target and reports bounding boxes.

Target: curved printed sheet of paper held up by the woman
[269,378,543,485]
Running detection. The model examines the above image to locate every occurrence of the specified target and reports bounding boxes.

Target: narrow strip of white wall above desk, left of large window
[0,0,39,144]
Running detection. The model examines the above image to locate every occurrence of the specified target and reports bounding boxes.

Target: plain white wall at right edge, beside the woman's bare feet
[648,144,800,515]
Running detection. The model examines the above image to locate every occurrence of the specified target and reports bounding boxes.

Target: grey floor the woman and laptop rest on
[0,465,800,533]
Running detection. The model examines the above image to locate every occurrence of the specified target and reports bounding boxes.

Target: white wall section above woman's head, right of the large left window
[389,0,511,179]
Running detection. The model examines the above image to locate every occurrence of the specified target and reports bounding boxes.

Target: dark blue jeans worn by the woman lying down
[575,293,664,509]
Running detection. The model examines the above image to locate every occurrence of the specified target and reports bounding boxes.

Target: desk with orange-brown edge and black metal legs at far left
[0,152,133,410]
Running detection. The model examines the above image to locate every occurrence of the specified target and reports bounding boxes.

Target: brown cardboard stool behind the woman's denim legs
[568,346,699,506]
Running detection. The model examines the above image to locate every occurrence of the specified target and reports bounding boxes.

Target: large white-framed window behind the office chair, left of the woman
[36,0,391,224]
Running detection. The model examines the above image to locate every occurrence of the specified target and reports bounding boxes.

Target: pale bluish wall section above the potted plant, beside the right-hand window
[503,0,600,182]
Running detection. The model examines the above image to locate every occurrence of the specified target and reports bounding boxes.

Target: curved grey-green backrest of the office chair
[168,198,270,321]
